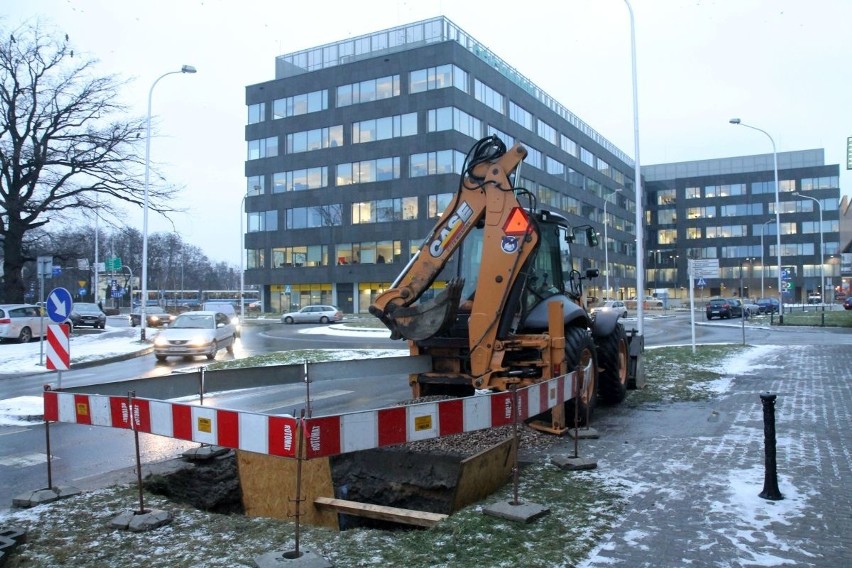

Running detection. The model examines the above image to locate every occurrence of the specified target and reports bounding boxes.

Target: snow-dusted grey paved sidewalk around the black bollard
[581,345,852,567]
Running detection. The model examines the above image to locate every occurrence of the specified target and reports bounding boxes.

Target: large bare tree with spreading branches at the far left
[0,23,174,302]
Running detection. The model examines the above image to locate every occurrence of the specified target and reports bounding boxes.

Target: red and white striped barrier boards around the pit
[44,372,576,459]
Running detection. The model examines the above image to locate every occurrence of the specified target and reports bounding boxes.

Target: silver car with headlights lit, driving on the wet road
[154,311,237,361]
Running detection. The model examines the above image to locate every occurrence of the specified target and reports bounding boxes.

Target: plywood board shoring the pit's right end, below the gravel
[452,438,518,513]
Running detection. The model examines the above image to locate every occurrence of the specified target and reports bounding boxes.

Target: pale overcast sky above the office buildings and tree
[5,0,852,265]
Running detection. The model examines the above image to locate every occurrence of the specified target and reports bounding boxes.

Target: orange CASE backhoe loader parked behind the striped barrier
[370,136,643,430]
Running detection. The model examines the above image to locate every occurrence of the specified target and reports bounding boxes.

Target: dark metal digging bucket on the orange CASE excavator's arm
[381,278,464,341]
